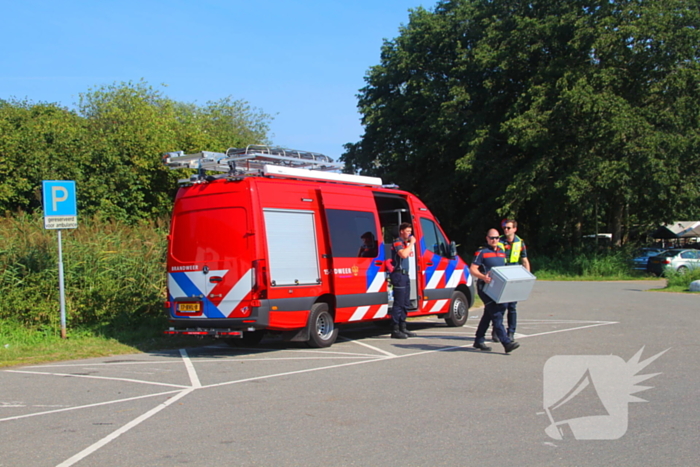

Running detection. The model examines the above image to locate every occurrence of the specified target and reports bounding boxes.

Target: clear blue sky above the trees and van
[0,0,434,158]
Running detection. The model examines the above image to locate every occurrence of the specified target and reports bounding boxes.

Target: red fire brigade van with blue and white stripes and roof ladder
[164,146,475,347]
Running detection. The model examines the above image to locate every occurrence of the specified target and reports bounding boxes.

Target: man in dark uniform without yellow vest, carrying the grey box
[469,229,520,353]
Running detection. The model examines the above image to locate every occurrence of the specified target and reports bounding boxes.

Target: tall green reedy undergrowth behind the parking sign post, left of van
[0,214,167,331]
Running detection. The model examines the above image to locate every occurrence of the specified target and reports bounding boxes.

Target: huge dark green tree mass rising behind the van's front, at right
[343,0,700,252]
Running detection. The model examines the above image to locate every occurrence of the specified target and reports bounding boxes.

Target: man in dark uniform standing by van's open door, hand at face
[389,222,416,339]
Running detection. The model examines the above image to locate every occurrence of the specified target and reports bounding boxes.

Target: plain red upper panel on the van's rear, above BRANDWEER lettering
[171,207,248,263]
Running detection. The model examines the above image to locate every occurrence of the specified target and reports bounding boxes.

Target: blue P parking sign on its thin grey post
[42,180,78,339]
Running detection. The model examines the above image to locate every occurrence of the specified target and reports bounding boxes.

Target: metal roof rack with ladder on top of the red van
[163,145,382,185]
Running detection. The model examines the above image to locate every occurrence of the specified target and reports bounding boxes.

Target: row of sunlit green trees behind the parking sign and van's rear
[0,81,271,222]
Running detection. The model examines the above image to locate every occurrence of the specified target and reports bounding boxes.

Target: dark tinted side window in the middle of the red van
[326,209,378,258]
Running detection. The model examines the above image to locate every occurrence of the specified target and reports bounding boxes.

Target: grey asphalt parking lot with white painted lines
[0,281,700,467]
